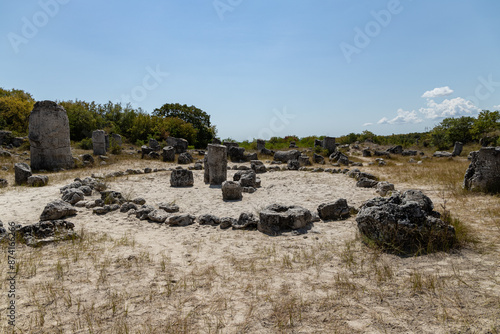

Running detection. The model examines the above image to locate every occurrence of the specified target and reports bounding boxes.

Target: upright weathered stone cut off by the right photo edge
[464,147,500,193]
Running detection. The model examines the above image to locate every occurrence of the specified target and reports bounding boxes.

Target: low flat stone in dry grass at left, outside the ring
[17,220,79,247]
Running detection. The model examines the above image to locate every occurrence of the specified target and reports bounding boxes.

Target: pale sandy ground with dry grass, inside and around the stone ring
[0,162,500,333]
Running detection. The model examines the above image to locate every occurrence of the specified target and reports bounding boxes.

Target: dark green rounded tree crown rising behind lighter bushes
[153,103,216,147]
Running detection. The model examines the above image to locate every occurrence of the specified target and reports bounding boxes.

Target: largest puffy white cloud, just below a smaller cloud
[419,97,481,119]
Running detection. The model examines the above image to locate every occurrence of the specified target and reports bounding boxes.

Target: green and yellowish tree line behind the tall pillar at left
[0,88,217,148]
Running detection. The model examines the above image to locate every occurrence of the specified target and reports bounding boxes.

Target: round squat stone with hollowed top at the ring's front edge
[257,204,312,235]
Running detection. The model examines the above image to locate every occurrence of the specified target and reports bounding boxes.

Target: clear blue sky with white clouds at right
[0,0,500,140]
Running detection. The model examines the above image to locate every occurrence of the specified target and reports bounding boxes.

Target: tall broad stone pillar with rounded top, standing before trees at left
[28,101,75,170]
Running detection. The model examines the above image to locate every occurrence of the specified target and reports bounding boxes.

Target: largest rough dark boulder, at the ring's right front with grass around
[356,190,456,254]
